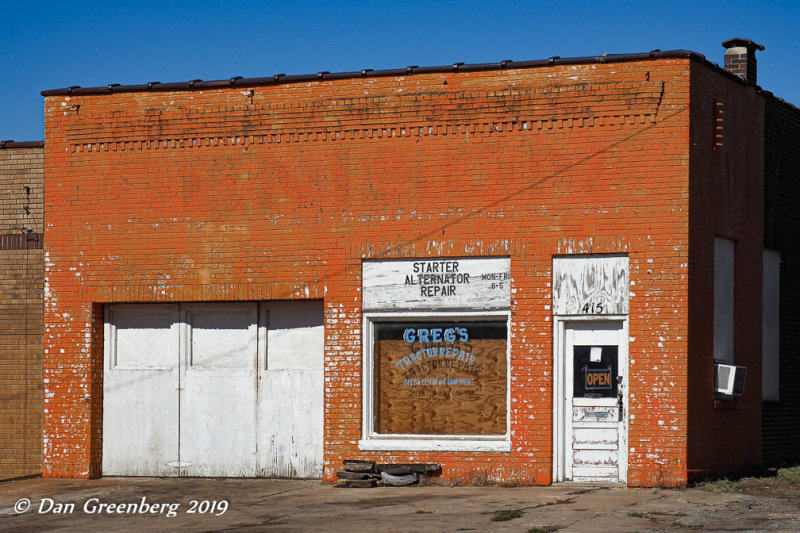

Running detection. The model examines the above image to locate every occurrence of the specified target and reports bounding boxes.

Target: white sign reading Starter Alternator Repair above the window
[363,257,511,311]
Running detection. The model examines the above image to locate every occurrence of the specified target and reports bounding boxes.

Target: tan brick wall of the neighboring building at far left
[0,143,44,478]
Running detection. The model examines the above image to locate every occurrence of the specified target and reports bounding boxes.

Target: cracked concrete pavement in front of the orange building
[0,478,800,533]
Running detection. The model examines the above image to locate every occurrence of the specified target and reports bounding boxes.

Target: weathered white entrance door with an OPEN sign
[562,320,628,482]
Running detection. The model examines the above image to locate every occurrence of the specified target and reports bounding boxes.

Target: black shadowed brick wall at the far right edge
[763,95,800,466]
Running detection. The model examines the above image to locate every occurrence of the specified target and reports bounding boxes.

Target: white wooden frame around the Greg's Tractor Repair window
[358,310,511,452]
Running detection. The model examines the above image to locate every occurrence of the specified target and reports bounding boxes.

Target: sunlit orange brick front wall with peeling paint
[44,59,691,485]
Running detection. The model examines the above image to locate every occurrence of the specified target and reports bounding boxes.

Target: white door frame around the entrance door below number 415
[552,315,630,483]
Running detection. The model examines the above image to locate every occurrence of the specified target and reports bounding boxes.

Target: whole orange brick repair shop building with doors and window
[43,41,796,486]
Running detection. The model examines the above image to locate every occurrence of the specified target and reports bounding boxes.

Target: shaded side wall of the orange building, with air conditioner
[688,64,764,478]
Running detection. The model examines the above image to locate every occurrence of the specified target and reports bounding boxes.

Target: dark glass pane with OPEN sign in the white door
[572,346,618,398]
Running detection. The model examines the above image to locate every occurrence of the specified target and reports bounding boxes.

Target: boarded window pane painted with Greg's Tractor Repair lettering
[374,321,508,435]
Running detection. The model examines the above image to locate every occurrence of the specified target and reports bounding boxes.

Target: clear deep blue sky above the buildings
[0,0,800,141]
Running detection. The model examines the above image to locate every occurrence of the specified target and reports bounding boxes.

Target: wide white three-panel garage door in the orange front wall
[103,302,323,477]
